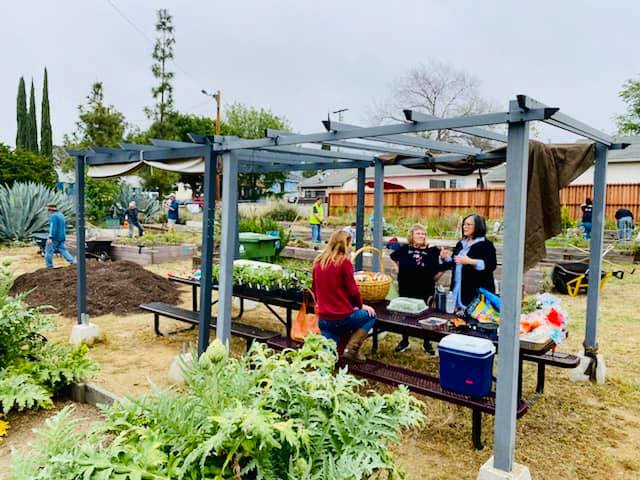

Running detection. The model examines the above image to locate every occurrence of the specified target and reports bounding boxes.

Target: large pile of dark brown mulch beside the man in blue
[11,260,180,317]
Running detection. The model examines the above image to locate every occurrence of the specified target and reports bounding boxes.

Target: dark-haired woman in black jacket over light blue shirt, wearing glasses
[445,214,497,309]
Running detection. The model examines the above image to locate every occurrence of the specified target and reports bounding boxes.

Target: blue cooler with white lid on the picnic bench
[438,334,496,397]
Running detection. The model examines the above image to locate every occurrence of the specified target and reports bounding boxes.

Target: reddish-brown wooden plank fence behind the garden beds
[329,183,640,220]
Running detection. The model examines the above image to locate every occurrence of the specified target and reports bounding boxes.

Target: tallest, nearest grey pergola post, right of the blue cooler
[488,101,530,478]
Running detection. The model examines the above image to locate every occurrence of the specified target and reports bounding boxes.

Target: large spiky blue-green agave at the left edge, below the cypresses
[0,182,75,242]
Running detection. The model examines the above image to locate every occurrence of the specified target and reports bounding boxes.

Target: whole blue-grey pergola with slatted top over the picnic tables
[69,95,627,472]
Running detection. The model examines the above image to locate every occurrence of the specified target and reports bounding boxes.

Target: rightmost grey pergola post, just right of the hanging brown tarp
[584,143,608,382]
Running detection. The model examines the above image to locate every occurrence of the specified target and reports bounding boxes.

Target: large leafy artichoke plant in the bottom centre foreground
[11,336,424,480]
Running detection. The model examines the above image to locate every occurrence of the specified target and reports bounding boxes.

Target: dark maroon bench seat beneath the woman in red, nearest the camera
[267,336,529,450]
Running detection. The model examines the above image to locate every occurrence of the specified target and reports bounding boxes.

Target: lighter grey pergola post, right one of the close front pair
[217,152,238,345]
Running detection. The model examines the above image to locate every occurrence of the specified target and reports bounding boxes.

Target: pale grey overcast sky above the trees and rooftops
[0,0,640,145]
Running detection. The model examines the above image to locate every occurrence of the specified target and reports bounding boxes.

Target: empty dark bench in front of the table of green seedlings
[140,302,279,350]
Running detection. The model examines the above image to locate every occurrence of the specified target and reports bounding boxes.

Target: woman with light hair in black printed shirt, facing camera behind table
[391,224,448,353]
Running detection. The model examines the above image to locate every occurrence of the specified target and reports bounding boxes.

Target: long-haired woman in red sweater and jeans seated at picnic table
[313,231,376,361]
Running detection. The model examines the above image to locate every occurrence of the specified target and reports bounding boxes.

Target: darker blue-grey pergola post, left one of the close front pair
[198,149,217,355]
